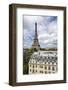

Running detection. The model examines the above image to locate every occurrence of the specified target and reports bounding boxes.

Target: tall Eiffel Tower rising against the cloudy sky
[32,23,40,50]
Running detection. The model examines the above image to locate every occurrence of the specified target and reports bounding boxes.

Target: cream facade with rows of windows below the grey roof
[29,60,57,74]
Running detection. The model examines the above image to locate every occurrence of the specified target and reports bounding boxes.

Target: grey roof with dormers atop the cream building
[31,51,57,62]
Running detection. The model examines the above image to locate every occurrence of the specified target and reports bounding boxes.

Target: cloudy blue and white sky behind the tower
[23,15,58,48]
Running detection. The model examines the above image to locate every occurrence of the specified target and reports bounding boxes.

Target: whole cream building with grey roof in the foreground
[28,51,57,74]
